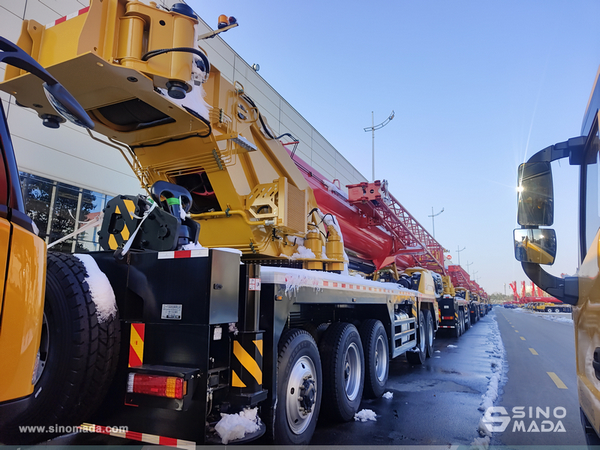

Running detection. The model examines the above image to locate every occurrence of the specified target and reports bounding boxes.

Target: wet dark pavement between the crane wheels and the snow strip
[311,313,500,447]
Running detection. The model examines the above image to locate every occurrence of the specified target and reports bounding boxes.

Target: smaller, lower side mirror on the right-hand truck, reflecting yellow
[513,228,556,265]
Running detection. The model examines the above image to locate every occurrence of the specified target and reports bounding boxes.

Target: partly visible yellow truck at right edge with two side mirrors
[514,60,600,445]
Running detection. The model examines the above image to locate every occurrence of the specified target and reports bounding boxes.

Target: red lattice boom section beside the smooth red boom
[348,181,446,275]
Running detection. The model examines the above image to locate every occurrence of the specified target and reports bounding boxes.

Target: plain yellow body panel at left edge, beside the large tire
[0,225,46,402]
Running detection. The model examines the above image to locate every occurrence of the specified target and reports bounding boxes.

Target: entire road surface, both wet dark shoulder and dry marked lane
[312,307,585,447]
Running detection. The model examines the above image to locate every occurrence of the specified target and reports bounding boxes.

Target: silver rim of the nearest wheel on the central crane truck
[285,356,318,434]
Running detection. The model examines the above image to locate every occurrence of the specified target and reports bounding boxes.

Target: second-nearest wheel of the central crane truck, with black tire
[319,322,365,422]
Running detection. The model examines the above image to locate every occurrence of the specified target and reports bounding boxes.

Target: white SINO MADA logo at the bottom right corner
[482,406,567,433]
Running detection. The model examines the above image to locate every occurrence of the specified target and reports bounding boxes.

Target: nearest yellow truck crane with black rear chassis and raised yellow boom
[0,0,450,446]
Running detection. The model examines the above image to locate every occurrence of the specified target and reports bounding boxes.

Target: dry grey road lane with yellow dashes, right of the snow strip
[492,308,585,446]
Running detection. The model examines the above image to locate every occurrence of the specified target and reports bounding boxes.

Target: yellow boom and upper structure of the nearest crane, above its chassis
[0,0,344,270]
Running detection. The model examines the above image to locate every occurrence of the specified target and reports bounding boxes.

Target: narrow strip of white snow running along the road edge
[471,314,507,449]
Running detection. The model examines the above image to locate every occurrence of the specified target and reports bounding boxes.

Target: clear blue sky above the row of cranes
[189,0,600,293]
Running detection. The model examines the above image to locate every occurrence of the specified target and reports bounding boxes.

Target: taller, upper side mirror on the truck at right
[517,162,554,226]
